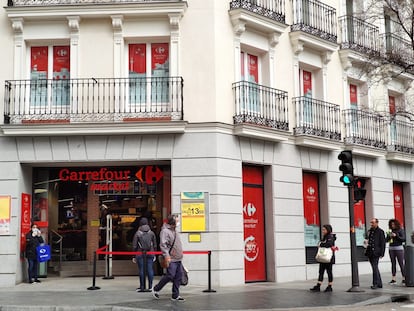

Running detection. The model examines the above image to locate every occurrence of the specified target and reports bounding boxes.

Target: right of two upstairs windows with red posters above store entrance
[128,43,170,104]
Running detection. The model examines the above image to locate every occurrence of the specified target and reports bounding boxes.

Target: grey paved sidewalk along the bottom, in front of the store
[0,272,414,311]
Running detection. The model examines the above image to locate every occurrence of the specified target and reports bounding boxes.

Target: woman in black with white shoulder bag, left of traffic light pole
[310,225,336,292]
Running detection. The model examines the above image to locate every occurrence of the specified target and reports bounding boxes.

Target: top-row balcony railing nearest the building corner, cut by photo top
[230,0,286,23]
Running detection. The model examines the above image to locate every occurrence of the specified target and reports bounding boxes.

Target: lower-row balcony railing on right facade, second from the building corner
[292,96,341,141]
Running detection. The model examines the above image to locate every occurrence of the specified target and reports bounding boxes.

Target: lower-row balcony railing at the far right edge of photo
[388,115,414,154]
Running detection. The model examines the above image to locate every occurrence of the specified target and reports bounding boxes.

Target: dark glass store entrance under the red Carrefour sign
[32,165,171,275]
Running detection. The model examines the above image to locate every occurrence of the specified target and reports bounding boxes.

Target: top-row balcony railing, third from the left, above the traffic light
[339,15,379,56]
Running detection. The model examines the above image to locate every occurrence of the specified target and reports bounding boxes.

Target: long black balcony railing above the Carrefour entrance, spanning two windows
[4,77,183,124]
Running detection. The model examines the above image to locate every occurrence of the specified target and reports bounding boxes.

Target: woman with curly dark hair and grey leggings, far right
[386,219,405,284]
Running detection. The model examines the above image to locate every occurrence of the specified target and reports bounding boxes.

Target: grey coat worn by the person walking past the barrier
[160,223,183,262]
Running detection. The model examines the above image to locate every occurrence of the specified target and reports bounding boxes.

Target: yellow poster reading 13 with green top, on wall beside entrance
[181,192,207,232]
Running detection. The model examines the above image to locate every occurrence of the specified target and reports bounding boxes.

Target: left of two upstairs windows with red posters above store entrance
[30,46,70,109]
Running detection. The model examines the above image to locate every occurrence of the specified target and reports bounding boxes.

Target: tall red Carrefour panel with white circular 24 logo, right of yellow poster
[243,166,266,282]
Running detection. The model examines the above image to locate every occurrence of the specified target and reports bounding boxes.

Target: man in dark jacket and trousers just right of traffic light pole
[365,218,385,289]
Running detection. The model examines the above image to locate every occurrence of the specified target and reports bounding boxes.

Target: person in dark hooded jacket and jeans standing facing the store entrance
[132,218,157,292]
